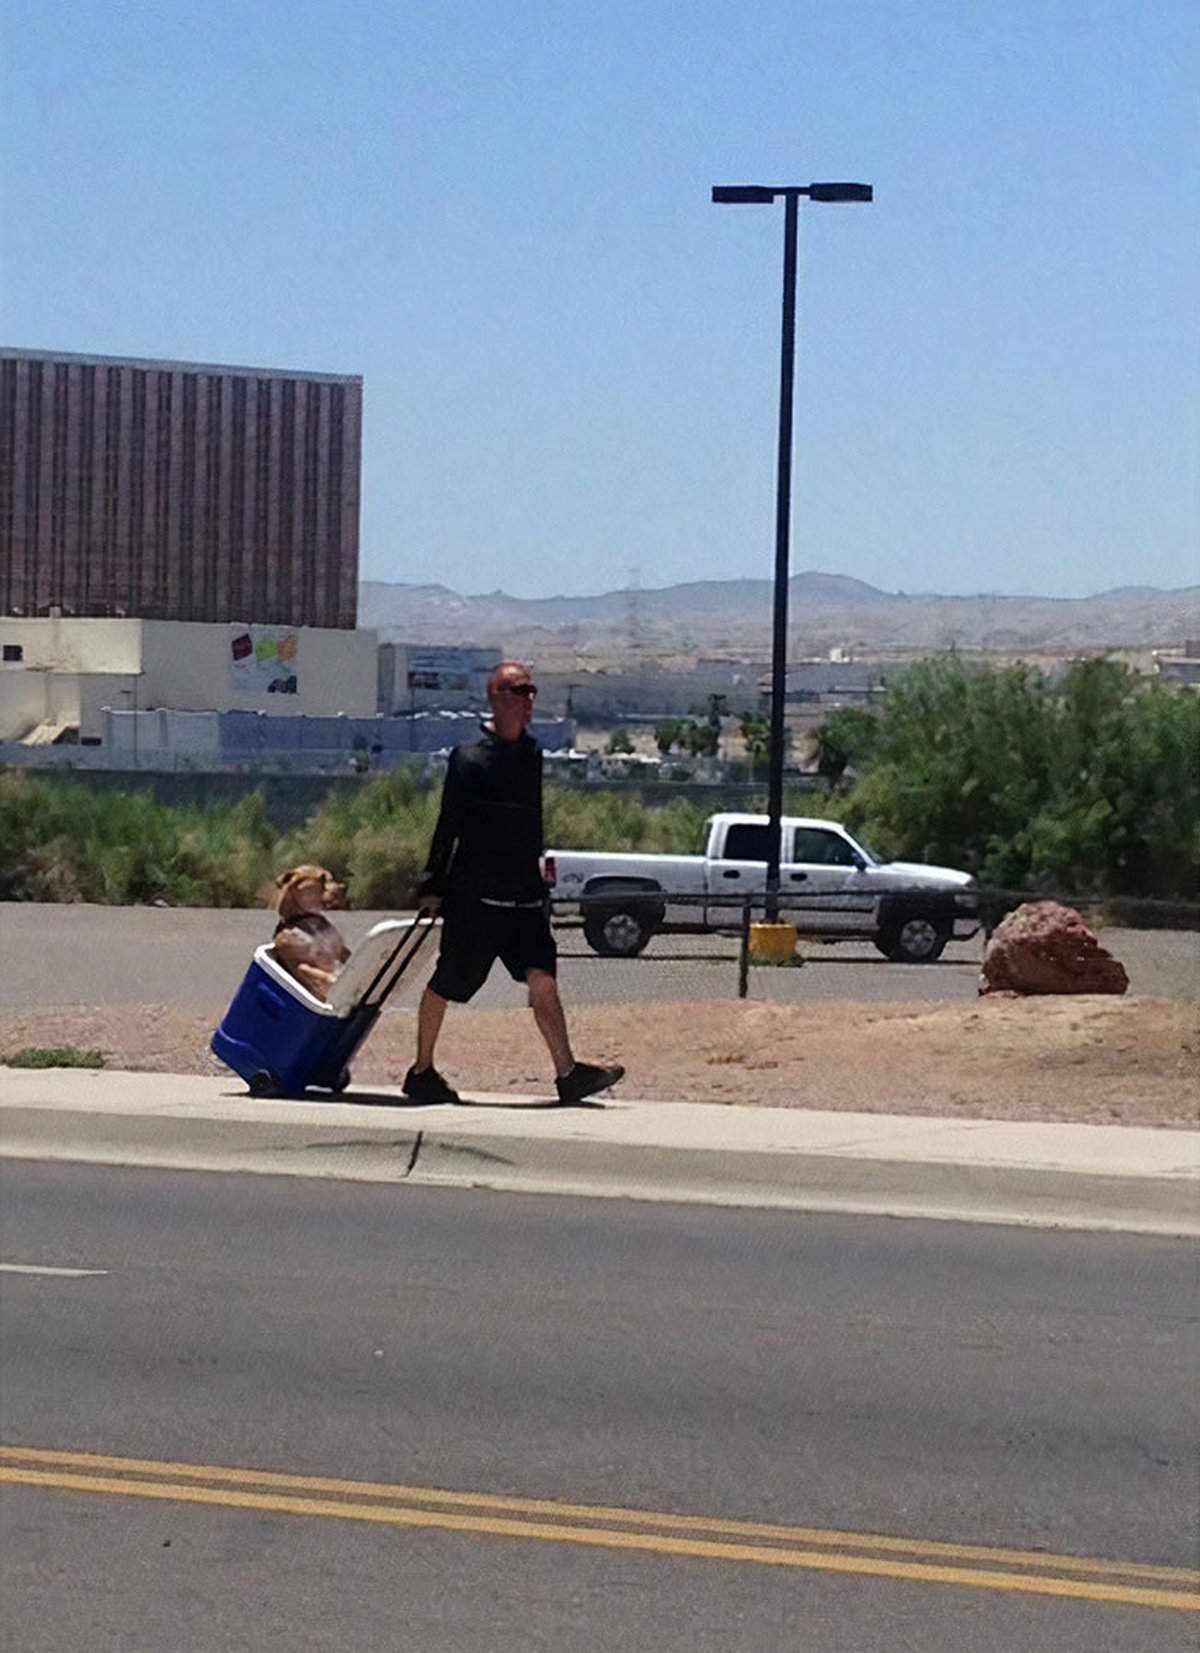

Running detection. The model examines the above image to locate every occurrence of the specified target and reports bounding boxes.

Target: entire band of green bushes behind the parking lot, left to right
[0,656,1200,909]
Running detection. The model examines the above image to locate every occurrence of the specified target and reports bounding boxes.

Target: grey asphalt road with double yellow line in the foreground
[0,1164,1197,1653]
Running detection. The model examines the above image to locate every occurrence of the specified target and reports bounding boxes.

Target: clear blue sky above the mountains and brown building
[0,0,1200,597]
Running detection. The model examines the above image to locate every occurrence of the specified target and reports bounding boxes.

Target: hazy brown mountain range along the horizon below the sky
[359,572,1200,658]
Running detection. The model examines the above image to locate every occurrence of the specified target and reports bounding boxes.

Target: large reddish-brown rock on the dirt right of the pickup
[979,901,1129,993]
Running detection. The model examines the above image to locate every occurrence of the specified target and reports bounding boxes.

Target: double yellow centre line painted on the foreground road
[0,1448,1200,1612]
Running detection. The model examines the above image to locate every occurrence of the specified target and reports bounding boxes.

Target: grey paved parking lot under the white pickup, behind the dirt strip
[0,903,1200,1008]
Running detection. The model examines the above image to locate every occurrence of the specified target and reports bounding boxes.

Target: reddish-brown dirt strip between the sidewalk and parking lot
[0,995,1200,1126]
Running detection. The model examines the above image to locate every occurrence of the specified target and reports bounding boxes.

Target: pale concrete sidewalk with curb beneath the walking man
[0,1068,1200,1236]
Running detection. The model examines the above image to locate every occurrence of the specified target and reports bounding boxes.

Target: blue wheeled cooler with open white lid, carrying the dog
[212,919,433,1096]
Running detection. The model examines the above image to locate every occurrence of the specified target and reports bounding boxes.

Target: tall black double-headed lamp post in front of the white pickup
[712,183,874,921]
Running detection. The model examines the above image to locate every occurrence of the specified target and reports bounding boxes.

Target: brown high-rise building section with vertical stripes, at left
[0,349,362,628]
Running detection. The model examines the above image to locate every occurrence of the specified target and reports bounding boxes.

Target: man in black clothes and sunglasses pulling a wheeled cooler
[403,660,625,1103]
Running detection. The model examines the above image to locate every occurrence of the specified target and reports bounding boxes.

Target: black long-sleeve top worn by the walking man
[417,726,545,904]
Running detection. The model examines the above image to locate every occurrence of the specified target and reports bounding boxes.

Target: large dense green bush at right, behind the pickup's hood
[843,656,1200,901]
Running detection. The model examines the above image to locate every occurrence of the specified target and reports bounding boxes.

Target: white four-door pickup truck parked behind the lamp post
[549,815,980,964]
